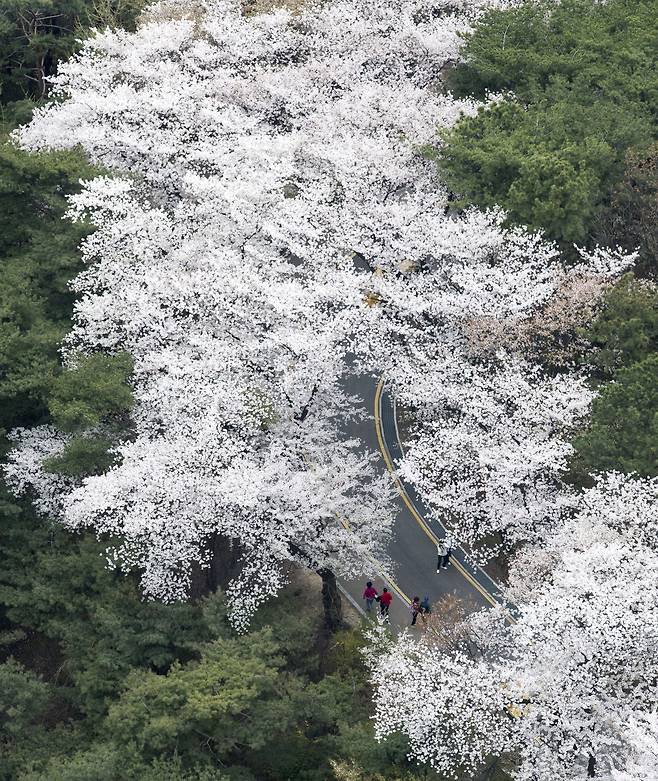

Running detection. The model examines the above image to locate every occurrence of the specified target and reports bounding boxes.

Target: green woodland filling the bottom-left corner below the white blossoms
[0,544,435,781]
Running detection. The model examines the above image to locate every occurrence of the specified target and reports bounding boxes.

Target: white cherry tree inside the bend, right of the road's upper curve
[364,222,632,560]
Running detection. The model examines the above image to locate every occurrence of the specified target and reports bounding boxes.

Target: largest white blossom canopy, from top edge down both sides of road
[9,0,627,622]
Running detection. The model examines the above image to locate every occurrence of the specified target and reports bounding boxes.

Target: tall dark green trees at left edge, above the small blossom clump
[0,116,92,429]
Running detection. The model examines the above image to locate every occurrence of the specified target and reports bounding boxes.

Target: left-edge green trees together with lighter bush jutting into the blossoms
[0,112,132,475]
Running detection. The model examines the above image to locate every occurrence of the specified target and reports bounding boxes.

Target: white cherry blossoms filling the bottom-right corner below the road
[370,474,658,781]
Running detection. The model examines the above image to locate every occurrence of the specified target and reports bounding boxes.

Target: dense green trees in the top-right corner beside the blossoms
[439,0,658,268]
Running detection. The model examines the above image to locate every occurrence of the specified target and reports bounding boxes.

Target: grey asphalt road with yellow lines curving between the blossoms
[341,377,513,628]
